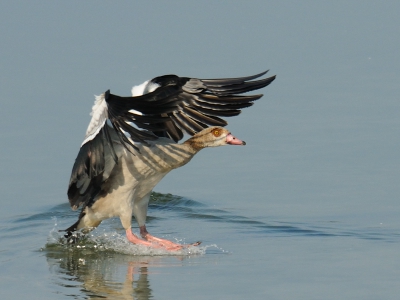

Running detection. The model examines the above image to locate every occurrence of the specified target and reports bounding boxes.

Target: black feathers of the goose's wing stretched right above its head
[105,71,275,144]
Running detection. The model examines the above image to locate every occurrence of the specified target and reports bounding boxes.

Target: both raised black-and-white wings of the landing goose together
[68,72,275,208]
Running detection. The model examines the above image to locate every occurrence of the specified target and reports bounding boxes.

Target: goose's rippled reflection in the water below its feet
[46,248,189,300]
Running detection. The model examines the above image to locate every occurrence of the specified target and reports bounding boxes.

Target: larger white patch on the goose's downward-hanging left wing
[81,94,108,146]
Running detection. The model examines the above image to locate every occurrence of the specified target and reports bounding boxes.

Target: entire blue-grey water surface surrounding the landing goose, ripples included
[0,0,400,300]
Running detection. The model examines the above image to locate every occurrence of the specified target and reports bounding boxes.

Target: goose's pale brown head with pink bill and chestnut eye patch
[185,127,246,150]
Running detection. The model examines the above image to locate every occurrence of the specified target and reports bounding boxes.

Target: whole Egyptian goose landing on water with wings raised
[62,71,276,251]
